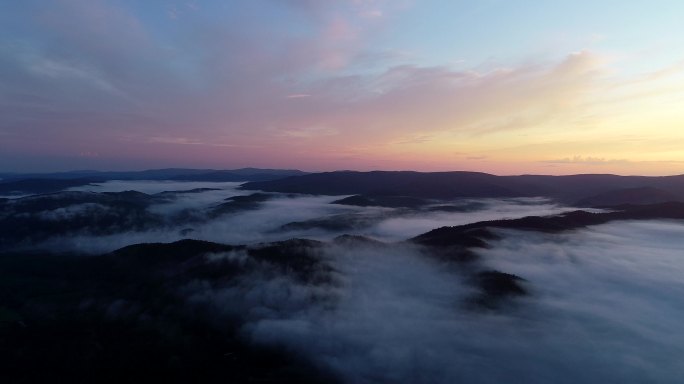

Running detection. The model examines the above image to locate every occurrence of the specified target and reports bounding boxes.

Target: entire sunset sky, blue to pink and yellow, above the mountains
[0,0,684,175]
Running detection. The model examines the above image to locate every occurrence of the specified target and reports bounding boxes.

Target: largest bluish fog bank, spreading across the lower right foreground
[187,221,684,384]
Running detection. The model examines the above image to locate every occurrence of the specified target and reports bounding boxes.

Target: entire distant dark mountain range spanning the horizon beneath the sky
[0,168,684,207]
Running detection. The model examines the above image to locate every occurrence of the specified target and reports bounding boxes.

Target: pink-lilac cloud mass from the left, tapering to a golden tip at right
[0,0,620,173]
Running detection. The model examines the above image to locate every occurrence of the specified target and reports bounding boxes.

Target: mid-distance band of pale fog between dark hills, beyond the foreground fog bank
[45,181,571,253]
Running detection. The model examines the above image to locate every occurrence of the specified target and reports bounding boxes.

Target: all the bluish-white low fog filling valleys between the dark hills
[9,182,684,384]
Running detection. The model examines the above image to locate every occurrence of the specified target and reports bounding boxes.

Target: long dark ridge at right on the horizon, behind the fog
[242,171,684,206]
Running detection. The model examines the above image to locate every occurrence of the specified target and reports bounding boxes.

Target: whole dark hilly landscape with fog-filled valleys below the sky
[0,173,684,383]
